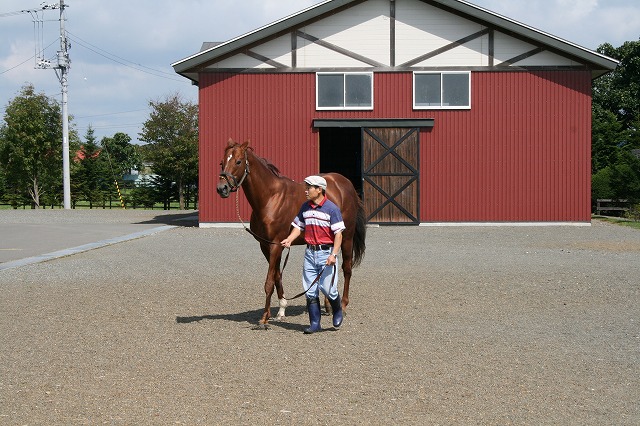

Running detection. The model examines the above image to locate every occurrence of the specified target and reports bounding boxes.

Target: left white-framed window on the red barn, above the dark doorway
[316,72,373,109]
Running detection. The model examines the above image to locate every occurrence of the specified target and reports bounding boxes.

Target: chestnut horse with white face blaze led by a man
[217,140,366,327]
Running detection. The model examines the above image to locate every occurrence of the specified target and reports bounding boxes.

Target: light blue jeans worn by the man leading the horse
[302,248,338,300]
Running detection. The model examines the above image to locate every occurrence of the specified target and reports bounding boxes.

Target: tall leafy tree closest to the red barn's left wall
[140,94,198,210]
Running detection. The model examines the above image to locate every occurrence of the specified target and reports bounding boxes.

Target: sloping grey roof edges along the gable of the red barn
[171,0,618,82]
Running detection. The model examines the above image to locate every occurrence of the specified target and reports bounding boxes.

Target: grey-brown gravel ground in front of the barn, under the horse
[0,212,640,425]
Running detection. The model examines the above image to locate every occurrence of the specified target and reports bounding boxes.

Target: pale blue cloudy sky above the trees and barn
[0,0,640,143]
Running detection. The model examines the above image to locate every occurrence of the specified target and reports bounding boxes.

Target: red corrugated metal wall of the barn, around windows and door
[200,71,591,222]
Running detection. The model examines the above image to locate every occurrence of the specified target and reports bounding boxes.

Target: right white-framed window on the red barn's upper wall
[413,72,471,109]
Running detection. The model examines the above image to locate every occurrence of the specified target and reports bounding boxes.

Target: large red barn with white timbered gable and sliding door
[173,0,617,226]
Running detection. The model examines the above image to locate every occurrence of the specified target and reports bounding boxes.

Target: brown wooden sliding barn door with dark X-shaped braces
[362,127,420,224]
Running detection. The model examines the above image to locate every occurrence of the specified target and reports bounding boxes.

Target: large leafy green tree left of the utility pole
[0,84,62,208]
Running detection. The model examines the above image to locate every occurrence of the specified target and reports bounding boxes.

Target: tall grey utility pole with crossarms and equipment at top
[23,0,71,209]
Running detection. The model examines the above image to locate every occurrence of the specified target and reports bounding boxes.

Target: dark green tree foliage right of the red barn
[592,40,640,206]
